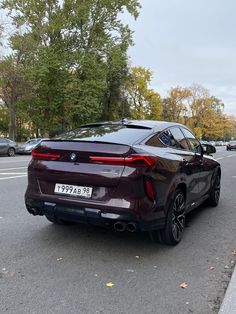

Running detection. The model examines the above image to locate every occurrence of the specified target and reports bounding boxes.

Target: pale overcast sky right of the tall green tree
[125,0,236,115]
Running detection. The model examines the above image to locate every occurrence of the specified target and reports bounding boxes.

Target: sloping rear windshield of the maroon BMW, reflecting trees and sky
[55,125,151,144]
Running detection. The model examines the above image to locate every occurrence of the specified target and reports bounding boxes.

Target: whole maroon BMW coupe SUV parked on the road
[25,120,221,245]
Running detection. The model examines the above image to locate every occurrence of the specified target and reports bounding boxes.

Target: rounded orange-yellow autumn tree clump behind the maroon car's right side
[163,84,233,140]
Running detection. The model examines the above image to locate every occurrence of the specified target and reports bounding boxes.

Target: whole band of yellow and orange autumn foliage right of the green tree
[126,67,236,140]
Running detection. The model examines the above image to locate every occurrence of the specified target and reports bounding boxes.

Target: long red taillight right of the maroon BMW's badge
[90,154,157,167]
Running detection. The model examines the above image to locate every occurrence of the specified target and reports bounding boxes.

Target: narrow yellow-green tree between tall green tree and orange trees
[126,67,162,120]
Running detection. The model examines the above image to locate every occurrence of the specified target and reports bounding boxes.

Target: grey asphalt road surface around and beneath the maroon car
[0,148,236,314]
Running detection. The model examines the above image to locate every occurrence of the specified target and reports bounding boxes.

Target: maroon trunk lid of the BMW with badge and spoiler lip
[29,140,136,200]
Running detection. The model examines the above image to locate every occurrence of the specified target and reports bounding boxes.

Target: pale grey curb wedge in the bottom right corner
[218,267,236,314]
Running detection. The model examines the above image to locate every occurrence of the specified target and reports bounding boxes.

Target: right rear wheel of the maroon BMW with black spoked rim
[149,190,186,245]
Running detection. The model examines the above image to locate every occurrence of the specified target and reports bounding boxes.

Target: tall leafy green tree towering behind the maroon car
[3,0,140,136]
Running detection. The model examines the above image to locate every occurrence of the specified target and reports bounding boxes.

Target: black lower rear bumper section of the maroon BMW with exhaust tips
[25,198,165,231]
